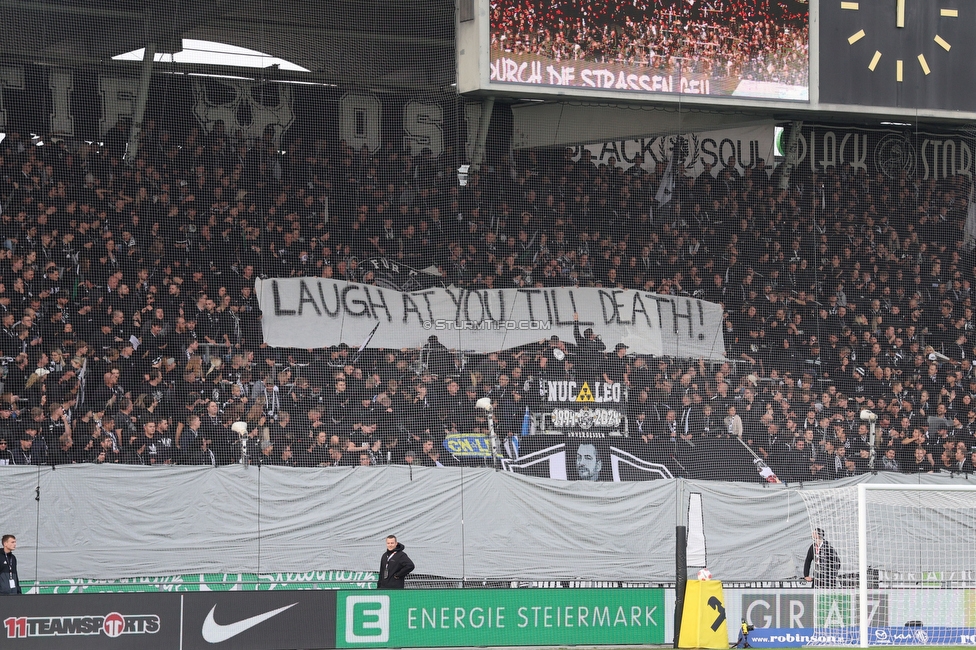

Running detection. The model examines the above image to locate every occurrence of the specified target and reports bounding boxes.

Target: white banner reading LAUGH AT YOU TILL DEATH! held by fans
[255,278,725,359]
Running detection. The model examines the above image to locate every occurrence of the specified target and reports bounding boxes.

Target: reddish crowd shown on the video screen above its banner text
[491,0,809,86]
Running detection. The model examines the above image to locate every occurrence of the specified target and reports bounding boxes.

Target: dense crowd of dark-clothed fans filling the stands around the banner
[0,115,976,480]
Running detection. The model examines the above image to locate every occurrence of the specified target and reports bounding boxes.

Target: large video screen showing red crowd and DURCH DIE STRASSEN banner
[489,0,810,101]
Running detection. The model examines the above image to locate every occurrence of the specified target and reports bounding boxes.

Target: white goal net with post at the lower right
[800,484,976,647]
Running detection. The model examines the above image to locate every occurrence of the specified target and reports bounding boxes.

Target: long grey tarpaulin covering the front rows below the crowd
[0,465,960,582]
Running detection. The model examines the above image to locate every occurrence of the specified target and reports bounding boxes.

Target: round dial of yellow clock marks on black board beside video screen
[834,0,959,83]
